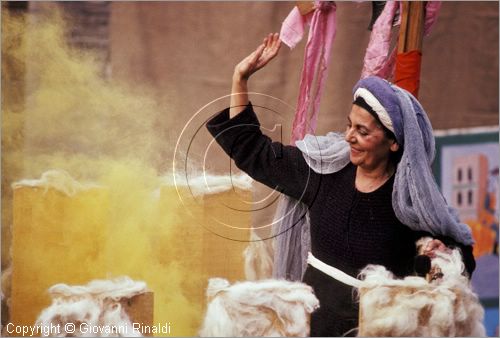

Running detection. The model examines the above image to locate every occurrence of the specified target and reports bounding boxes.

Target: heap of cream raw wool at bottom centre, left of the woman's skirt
[199,278,319,337]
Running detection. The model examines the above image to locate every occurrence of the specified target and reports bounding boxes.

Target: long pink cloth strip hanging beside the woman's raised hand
[280,1,336,144]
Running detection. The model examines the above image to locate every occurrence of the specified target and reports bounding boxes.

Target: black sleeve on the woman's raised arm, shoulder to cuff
[207,103,321,205]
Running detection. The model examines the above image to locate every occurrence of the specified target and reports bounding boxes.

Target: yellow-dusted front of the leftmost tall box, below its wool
[9,187,110,325]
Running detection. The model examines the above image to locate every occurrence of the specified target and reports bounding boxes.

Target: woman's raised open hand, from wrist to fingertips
[234,33,281,80]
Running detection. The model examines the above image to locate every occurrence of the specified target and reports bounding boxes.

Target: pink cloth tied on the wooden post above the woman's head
[361,1,441,79]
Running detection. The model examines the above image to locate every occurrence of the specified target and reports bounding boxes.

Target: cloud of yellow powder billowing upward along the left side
[2,11,218,336]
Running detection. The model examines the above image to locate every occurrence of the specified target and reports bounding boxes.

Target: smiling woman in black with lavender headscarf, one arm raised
[207,34,475,336]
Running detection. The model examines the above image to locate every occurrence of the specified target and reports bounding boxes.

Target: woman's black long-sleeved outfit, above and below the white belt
[207,104,475,336]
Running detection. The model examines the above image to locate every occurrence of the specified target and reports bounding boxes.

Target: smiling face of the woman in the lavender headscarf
[345,105,399,170]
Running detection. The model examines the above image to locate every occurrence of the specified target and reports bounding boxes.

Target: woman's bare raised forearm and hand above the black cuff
[229,33,281,118]
